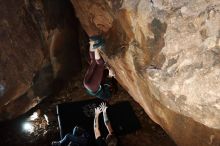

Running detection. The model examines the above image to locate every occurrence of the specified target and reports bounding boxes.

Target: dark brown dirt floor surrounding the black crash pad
[0,75,176,146]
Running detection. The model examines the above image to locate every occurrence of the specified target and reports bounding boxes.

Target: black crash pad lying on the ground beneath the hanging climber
[56,99,140,138]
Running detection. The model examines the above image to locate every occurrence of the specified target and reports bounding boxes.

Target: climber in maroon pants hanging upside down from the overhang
[84,36,117,100]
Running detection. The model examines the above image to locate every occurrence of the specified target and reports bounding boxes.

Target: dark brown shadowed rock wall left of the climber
[0,0,81,121]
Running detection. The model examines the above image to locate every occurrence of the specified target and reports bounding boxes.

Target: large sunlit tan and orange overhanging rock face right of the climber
[72,0,220,146]
